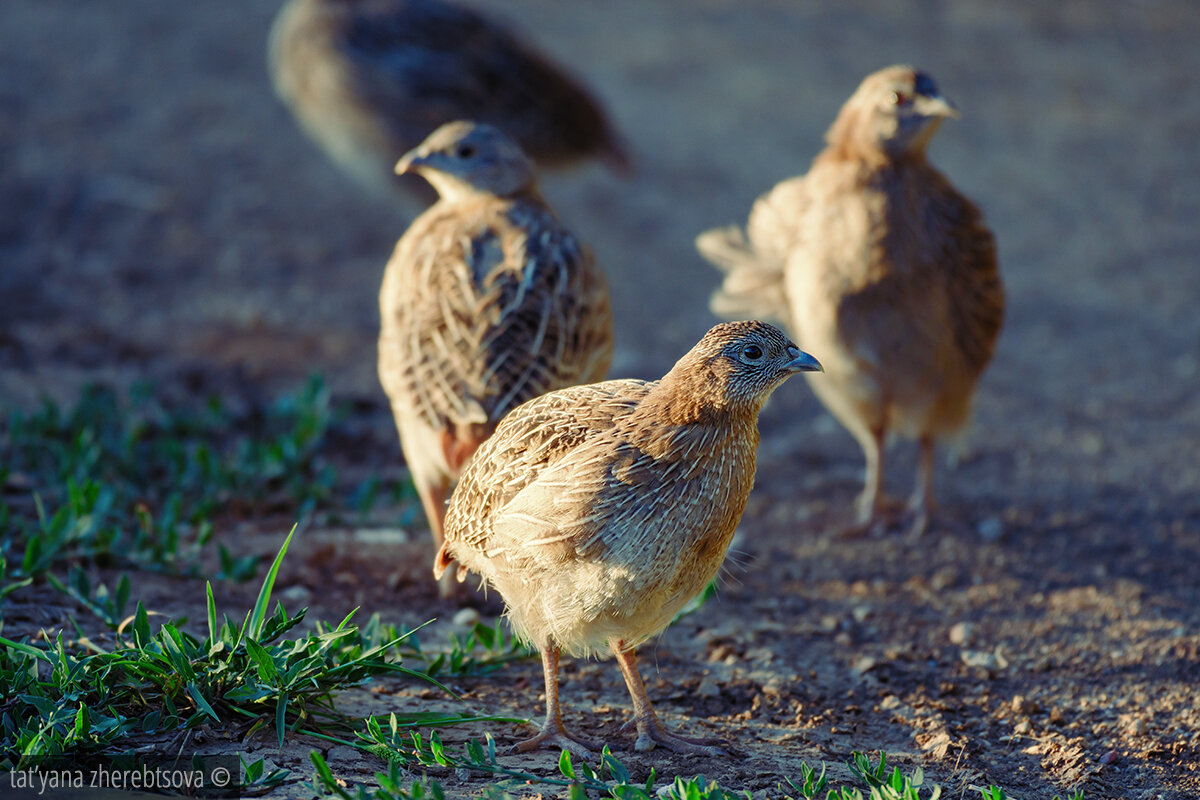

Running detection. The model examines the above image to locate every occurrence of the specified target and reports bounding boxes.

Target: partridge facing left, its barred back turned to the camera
[379,122,612,593]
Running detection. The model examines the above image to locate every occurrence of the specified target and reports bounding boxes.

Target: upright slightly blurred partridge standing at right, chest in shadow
[696,66,1004,534]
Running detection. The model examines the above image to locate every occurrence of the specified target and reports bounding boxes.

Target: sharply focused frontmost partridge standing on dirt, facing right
[433,321,821,758]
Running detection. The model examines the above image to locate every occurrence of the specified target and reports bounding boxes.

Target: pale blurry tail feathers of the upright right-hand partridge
[696,225,788,325]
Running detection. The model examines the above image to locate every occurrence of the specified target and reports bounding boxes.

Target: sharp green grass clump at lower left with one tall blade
[0,529,488,769]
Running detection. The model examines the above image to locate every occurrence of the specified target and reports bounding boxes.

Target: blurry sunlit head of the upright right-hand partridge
[826,66,959,157]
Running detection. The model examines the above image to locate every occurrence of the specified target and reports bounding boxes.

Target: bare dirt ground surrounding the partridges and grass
[0,0,1200,800]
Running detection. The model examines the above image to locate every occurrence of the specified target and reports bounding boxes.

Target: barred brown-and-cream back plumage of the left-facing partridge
[379,193,612,479]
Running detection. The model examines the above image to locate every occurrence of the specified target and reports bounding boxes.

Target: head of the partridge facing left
[396,121,535,199]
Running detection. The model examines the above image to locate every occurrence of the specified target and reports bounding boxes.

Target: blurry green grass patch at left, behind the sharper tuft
[0,378,418,626]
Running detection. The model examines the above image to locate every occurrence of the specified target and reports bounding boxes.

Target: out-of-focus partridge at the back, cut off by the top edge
[269,0,629,196]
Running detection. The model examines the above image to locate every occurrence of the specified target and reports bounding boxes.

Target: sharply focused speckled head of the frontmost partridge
[662,320,822,415]
